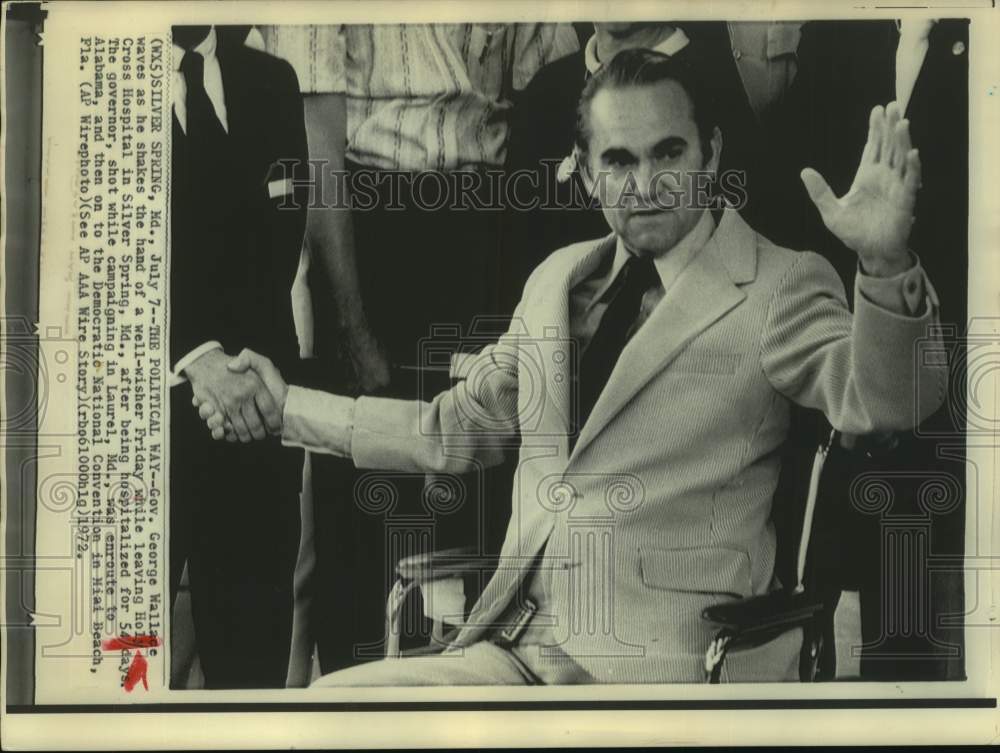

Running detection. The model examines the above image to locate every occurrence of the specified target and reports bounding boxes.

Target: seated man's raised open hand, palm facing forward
[802,102,920,277]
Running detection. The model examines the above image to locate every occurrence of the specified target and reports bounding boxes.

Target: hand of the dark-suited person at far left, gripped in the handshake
[184,350,281,442]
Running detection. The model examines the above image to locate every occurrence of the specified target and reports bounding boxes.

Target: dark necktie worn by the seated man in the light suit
[573,254,660,442]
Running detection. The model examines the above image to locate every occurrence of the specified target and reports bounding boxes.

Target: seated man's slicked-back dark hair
[575,49,719,169]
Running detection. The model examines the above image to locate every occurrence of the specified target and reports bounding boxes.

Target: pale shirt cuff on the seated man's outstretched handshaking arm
[281,386,355,458]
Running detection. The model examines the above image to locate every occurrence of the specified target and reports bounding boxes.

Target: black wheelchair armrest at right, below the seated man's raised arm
[701,589,826,642]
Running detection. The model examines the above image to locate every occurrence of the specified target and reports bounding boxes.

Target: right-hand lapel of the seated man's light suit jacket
[570,210,757,460]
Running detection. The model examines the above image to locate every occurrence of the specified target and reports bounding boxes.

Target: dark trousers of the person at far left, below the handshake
[170,384,302,688]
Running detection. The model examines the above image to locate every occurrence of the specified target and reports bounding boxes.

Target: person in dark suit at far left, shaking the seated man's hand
[170,26,307,688]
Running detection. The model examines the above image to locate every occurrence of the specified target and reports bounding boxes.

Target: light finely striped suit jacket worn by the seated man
[334,210,947,682]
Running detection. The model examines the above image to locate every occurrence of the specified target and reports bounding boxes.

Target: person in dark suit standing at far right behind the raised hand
[768,17,969,680]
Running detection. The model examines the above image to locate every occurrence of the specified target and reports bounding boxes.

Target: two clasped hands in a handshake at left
[184,349,288,442]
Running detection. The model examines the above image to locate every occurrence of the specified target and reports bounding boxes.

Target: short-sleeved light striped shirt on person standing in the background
[261,23,579,171]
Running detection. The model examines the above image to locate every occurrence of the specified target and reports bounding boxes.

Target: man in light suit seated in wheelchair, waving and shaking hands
[193,50,947,686]
